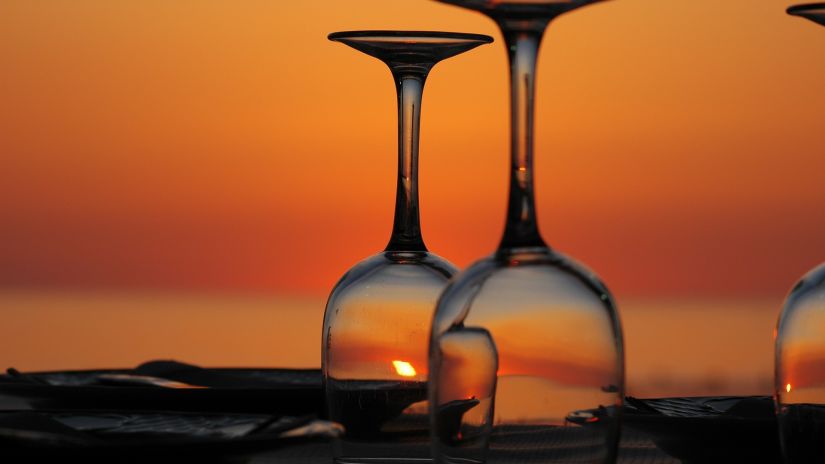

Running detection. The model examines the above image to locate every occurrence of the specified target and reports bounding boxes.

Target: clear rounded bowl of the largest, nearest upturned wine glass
[430,248,624,463]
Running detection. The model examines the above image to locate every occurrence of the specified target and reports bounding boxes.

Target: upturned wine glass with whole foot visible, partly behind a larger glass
[321,31,493,463]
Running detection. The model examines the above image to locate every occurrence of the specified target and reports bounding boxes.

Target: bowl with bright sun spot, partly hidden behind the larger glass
[324,251,456,438]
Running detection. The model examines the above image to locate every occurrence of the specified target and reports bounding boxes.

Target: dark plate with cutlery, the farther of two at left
[0,361,324,416]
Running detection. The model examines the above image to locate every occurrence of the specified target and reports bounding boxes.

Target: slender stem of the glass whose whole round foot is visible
[386,72,427,251]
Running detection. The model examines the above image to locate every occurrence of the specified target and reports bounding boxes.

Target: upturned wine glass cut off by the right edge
[774,7,825,464]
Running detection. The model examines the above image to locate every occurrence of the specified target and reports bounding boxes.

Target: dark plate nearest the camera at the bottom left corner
[0,410,340,462]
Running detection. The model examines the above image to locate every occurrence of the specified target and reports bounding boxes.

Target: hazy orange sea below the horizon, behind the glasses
[0,290,781,397]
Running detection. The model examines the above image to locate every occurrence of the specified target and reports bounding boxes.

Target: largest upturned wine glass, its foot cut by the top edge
[429,0,624,463]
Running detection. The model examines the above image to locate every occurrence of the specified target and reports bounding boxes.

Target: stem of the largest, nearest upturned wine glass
[499,28,546,249]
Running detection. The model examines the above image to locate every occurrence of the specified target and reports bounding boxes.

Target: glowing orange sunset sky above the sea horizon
[0,0,825,297]
